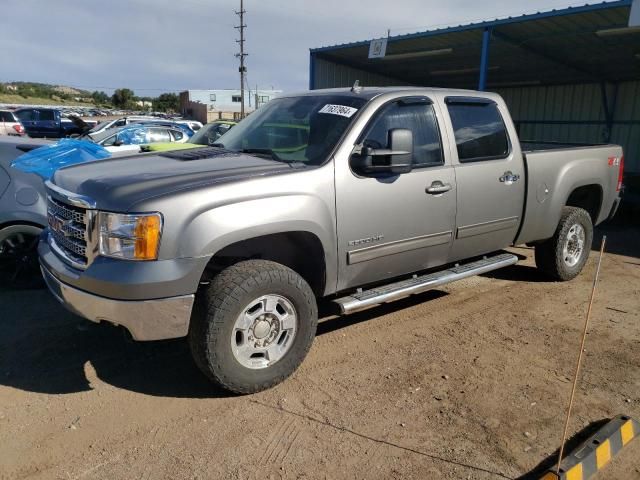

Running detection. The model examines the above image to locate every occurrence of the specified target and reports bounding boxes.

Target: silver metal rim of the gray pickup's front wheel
[231,294,298,370]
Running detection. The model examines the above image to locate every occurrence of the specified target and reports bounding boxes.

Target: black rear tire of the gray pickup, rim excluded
[535,207,593,282]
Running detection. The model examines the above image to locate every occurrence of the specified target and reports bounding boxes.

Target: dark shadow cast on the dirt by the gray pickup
[0,284,446,398]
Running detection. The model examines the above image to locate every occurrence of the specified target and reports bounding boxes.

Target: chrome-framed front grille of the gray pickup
[47,197,89,267]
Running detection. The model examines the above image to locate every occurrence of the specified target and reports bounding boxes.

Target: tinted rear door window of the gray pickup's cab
[448,102,509,163]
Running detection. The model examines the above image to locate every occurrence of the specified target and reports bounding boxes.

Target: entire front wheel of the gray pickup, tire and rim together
[189,260,318,393]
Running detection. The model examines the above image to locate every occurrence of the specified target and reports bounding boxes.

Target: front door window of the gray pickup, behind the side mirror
[364,101,444,168]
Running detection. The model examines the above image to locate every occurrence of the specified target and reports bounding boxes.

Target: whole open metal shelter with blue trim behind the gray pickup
[309,0,640,177]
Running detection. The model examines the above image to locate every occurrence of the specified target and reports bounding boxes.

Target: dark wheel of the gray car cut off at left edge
[0,225,44,288]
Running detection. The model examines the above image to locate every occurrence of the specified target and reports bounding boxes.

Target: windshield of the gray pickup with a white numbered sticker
[217,95,367,165]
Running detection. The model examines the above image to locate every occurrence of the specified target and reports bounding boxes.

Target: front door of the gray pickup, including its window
[335,97,456,289]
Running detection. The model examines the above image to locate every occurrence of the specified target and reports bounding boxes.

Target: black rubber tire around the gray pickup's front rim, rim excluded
[189,260,318,394]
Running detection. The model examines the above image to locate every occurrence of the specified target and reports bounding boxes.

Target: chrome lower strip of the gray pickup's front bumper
[40,266,195,340]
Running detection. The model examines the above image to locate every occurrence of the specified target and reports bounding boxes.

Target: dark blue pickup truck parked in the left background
[13,107,87,138]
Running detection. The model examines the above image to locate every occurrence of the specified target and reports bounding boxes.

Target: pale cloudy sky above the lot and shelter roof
[0,0,604,97]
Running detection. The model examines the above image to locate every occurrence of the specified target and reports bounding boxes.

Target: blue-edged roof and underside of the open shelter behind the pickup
[309,0,640,89]
